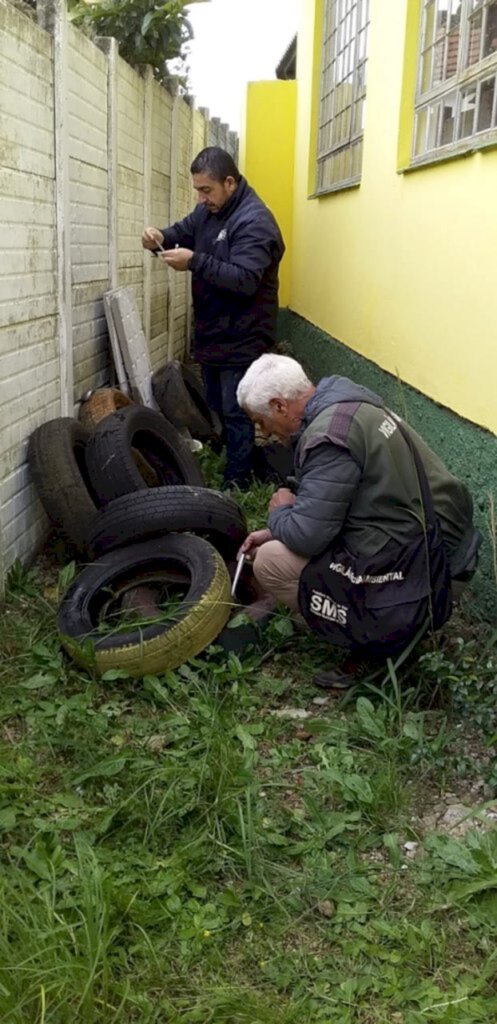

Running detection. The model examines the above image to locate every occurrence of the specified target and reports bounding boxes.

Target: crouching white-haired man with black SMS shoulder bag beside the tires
[237,354,482,686]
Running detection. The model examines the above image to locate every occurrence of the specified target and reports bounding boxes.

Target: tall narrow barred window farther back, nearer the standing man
[317,0,370,193]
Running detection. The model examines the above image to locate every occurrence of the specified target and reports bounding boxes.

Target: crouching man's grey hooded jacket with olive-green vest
[270,377,478,575]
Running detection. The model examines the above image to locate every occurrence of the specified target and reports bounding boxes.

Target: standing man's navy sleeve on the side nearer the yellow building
[190,220,282,296]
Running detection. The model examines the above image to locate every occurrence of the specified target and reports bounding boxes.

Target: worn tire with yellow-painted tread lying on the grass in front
[57,534,232,678]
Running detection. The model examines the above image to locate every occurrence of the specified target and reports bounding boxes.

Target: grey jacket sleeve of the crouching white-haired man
[268,442,361,558]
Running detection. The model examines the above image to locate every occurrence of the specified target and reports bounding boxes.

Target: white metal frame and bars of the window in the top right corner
[411,0,497,166]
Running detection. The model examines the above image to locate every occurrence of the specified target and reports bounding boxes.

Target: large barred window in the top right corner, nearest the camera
[413,0,497,163]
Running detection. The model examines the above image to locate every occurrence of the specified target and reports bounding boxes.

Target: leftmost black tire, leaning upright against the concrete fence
[28,417,97,553]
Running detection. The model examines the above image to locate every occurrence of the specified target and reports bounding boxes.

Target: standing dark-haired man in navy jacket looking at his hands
[141,146,285,486]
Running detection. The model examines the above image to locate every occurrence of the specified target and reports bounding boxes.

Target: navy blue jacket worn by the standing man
[163,178,285,368]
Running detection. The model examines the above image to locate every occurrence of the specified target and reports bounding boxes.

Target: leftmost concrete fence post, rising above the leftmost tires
[37,0,73,416]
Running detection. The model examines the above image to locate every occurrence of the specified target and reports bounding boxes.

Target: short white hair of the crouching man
[237,352,313,416]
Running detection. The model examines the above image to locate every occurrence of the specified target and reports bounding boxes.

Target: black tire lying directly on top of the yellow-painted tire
[88,485,247,560]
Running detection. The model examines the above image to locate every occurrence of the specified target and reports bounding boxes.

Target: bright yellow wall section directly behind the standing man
[240,81,296,306]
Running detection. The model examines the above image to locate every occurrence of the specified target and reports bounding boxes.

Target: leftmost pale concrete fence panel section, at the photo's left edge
[0,3,60,588]
